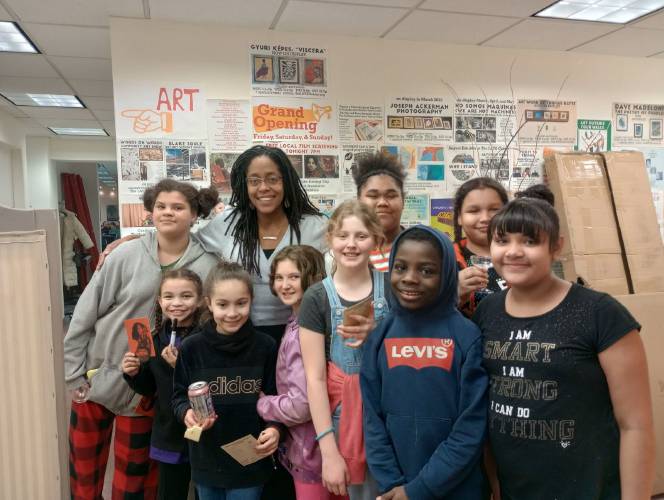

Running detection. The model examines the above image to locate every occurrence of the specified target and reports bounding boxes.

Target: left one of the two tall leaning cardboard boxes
[545,152,629,295]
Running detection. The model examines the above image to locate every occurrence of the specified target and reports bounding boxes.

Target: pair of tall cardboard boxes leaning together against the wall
[546,151,664,295]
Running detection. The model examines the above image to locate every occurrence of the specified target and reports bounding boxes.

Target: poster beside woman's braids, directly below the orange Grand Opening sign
[265,142,342,196]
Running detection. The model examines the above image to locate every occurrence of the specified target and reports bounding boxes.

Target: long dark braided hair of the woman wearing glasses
[226,145,321,276]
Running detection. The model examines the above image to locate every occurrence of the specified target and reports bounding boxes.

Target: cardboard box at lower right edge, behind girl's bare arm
[616,293,664,495]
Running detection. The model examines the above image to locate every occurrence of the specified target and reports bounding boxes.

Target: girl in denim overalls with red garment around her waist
[299,200,388,500]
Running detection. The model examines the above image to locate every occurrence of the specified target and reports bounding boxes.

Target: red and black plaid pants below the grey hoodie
[69,401,157,500]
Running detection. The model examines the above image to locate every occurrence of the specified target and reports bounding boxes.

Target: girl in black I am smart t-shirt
[473,199,655,500]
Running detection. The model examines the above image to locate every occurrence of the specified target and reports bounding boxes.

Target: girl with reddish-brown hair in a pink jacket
[257,245,340,500]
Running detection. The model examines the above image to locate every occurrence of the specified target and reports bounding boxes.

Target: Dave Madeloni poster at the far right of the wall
[612,102,664,146]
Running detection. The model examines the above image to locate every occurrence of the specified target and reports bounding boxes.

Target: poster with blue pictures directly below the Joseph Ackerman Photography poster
[380,145,447,193]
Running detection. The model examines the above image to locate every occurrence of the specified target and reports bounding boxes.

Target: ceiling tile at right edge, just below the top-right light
[574,28,664,57]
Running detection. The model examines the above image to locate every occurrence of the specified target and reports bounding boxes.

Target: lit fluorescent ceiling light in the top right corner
[535,0,664,24]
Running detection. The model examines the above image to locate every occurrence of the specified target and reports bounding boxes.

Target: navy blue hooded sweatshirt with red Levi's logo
[360,226,488,500]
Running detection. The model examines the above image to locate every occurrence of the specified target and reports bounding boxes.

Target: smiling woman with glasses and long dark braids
[198,145,326,342]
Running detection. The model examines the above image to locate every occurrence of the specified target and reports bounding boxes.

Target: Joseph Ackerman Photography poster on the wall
[385,96,453,144]
